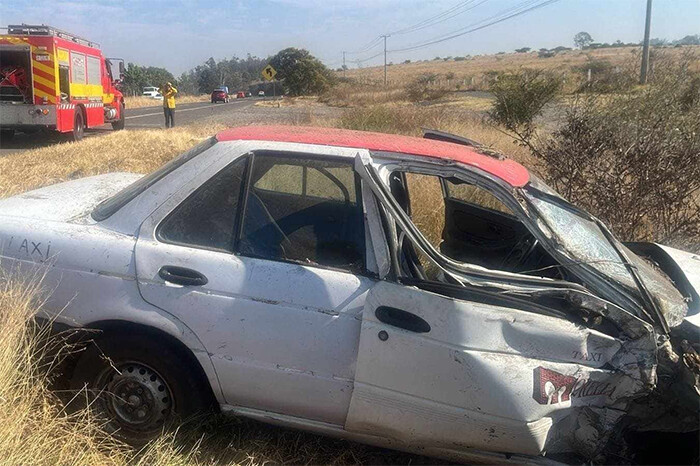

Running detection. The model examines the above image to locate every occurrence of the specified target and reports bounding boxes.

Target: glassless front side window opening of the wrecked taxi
[389,172,560,280]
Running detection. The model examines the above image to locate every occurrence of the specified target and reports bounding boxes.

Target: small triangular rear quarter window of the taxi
[157,158,246,252]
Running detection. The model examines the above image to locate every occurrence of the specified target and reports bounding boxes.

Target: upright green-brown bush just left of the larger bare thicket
[489,70,562,141]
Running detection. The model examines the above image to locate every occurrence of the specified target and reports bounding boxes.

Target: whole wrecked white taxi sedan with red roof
[0,127,700,462]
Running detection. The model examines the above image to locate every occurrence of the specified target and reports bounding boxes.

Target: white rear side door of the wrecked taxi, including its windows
[136,149,374,425]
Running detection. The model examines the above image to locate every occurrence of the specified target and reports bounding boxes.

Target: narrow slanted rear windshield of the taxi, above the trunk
[92,137,216,222]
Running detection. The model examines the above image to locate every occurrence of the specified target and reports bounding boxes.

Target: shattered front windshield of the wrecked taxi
[524,186,688,327]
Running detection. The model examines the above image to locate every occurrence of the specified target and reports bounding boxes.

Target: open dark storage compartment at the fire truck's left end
[0,45,33,104]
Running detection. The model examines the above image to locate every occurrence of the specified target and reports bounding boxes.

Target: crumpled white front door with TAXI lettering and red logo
[346,152,655,455]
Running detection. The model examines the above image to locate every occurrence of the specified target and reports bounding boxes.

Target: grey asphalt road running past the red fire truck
[0,97,261,157]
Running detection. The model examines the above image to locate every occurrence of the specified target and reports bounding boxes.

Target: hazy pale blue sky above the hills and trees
[0,0,700,76]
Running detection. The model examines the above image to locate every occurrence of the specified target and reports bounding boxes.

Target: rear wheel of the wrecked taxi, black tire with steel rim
[70,333,213,446]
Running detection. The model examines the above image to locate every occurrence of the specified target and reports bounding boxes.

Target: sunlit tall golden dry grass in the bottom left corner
[0,280,127,465]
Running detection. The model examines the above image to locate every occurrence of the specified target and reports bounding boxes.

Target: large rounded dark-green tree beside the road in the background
[270,47,335,96]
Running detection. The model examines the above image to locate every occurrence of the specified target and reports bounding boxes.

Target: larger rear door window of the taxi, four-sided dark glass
[239,154,364,272]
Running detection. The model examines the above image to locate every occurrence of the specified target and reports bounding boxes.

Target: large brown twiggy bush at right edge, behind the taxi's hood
[534,59,700,251]
